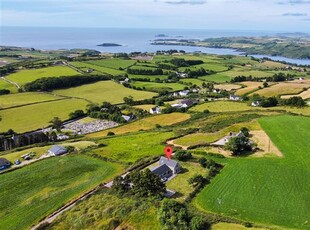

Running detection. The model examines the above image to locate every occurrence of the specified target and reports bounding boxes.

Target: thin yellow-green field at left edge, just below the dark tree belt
[0,93,61,109]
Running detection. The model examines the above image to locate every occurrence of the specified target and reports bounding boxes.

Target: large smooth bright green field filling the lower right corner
[194,116,310,229]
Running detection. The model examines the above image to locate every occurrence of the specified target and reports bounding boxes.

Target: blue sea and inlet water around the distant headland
[0,27,310,65]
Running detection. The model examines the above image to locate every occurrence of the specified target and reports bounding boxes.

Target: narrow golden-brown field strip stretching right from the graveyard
[87,113,190,138]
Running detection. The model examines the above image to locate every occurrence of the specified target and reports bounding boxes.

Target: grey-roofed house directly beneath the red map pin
[151,157,181,181]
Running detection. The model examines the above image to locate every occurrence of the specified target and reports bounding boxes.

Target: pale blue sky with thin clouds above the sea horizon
[0,0,310,32]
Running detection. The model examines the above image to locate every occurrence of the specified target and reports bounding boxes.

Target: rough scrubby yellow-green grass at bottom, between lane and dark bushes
[51,190,161,230]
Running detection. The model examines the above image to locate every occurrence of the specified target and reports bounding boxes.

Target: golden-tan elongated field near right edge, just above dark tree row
[250,82,310,97]
